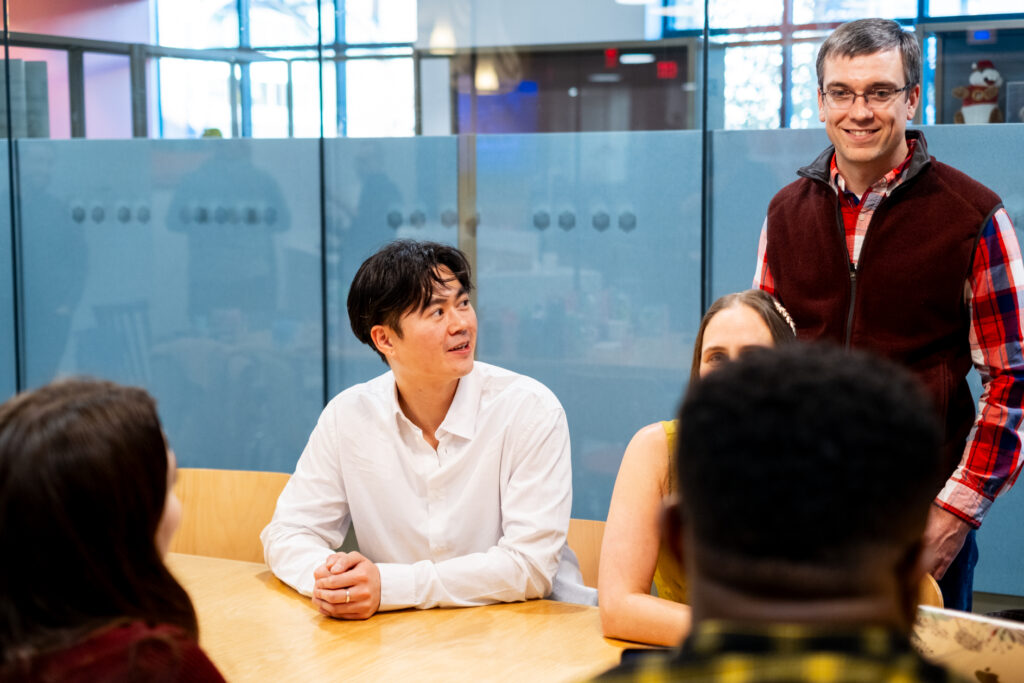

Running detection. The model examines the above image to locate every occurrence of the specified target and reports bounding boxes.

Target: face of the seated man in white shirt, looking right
[371,266,476,384]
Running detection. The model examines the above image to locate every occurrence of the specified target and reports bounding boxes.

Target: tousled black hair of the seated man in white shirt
[348,240,473,362]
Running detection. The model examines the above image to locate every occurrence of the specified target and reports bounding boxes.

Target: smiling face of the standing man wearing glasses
[818,49,921,183]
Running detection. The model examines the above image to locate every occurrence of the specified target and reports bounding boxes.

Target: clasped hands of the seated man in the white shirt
[313,553,381,620]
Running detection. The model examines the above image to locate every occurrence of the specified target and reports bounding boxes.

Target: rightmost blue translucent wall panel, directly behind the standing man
[712,124,1024,595]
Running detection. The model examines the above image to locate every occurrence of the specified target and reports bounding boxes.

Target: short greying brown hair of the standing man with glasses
[815,18,922,91]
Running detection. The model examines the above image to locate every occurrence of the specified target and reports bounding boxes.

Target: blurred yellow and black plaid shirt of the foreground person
[597,622,964,683]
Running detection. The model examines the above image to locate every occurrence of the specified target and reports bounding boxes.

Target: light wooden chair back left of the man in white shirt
[170,468,290,562]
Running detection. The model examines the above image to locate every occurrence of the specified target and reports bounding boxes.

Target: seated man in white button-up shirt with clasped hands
[260,240,596,618]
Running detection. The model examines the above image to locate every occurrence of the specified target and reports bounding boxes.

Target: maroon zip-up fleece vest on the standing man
[768,131,1001,462]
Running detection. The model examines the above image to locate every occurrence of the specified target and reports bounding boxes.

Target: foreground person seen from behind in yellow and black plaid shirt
[600,344,957,683]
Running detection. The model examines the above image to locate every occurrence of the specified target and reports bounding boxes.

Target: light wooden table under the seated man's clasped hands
[167,553,630,683]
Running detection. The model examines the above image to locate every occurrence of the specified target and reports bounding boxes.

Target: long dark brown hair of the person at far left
[0,379,198,678]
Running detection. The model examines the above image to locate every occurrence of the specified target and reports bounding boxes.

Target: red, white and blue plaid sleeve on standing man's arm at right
[937,208,1024,526]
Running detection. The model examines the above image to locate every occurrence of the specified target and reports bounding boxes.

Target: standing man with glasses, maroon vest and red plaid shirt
[754,18,1024,610]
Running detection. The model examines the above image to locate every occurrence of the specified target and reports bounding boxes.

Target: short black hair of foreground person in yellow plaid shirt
[676,344,943,582]
